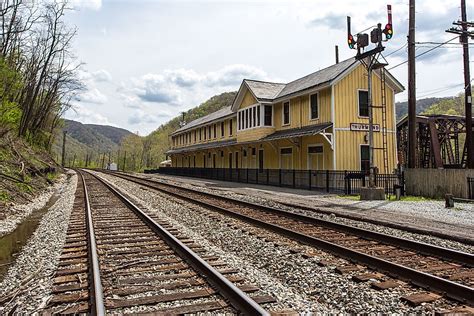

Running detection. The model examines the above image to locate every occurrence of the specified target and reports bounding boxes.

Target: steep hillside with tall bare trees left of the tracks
[0,1,83,205]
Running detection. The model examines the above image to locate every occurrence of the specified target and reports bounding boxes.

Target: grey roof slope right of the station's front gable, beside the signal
[275,57,358,99]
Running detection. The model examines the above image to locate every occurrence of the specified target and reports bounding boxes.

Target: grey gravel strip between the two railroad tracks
[95,175,462,313]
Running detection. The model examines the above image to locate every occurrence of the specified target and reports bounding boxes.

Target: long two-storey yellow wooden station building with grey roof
[167,58,404,172]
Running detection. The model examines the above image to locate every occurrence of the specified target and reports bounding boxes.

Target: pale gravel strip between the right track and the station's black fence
[145,174,474,244]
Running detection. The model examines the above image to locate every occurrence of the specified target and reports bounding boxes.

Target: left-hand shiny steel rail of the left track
[76,170,106,316]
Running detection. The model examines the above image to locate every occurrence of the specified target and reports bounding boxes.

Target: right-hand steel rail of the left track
[83,172,270,316]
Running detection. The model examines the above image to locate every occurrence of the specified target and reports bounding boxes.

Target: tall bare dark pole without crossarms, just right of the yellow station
[408,0,416,168]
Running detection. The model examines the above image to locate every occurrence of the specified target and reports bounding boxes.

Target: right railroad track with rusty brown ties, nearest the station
[101,172,474,306]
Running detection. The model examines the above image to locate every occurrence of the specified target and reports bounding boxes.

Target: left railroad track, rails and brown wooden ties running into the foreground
[46,171,275,315]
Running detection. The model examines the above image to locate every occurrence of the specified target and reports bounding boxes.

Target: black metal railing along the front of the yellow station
[145,167,404,195]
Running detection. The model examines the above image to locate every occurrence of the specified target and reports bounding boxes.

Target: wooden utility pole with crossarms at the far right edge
[446,0,474,169]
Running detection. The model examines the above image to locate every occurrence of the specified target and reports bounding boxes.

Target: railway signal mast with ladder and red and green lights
[347,4,393,188]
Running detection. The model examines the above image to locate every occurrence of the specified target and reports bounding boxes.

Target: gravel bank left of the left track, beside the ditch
[0,174,77,315]
